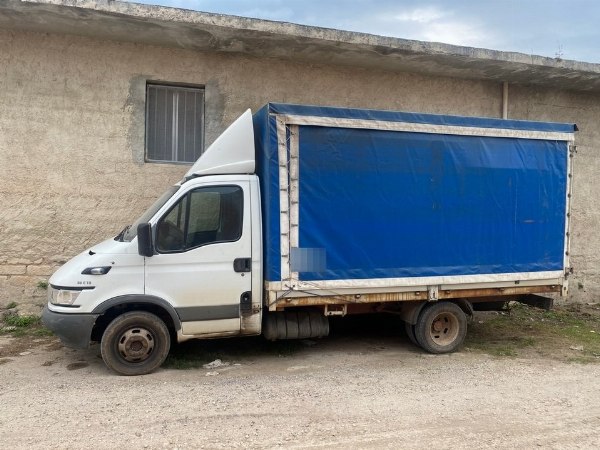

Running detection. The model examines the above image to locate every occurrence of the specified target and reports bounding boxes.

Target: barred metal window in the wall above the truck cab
[146,84,204,163]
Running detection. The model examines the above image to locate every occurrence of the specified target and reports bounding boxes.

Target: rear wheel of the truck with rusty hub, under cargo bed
[415,302,467,353]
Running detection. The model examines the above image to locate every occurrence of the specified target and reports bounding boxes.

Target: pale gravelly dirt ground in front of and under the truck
[0,317,600,449]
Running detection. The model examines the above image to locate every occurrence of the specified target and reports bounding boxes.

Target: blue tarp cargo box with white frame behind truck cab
[254,103,576,308]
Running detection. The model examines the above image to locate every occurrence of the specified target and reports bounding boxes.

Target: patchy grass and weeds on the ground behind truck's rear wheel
[465,304,600,363]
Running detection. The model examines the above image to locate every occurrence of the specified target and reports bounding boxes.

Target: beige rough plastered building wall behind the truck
[0,30,600,309]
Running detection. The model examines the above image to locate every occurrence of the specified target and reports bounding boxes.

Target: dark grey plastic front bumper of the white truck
[42,306,100,348]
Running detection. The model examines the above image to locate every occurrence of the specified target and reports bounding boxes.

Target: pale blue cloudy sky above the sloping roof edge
[135,0,600,63]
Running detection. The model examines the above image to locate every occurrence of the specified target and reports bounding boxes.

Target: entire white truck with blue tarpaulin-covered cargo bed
[42,103,577,375]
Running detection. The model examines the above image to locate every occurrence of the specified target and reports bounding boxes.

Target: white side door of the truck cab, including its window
[145,182,252,335]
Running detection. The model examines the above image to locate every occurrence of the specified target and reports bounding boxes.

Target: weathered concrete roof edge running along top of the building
[0,0,600,92]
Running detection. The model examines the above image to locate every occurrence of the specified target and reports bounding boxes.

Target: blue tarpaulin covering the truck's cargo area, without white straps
[254,103,575,281]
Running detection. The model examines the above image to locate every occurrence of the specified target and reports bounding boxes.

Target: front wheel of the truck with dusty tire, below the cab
[100,311,171,375]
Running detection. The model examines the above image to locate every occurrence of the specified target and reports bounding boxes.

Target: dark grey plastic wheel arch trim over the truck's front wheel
[92,295,181,342]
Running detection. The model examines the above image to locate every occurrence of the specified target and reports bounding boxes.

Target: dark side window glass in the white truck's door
[156,186,244,253]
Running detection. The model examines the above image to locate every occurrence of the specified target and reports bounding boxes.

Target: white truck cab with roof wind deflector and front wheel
[43,110,262,375]
